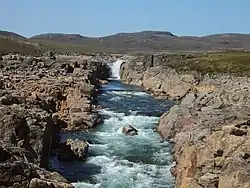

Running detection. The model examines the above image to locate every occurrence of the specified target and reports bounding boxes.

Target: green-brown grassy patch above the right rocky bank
[162,51,250,77]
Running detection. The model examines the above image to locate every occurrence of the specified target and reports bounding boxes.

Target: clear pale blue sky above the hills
[0,0,250,37]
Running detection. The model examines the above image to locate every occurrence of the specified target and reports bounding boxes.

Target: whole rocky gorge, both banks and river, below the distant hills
[0,52,250,188]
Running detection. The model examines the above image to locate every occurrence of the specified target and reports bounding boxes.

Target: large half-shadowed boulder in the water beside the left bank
[58,139,89,161]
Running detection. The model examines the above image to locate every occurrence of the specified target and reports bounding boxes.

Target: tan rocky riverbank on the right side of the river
[121,55,250,188]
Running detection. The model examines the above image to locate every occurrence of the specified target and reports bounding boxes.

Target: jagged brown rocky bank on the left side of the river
[0,53,112,188]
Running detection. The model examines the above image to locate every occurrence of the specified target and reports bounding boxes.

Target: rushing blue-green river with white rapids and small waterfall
[50,62,174,188]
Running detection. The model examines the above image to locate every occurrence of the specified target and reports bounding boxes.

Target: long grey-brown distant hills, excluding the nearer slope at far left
[31,31,250,52]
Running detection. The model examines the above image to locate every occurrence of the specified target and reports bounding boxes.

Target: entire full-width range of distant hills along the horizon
[0,31,250,53]
